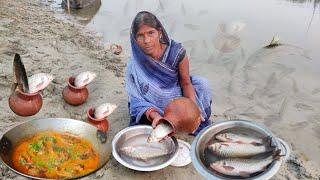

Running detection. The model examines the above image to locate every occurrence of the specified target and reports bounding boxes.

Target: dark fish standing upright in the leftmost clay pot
[11,54,29,92]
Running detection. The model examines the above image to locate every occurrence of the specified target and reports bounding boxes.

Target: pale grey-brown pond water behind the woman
[55,0,320,167]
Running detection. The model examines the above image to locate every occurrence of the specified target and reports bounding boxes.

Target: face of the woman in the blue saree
[136,25,160,56]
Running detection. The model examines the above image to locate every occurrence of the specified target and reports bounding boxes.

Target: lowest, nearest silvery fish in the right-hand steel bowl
[210,150,280,177]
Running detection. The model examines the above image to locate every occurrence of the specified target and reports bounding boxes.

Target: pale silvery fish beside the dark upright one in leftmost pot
[28,73,54,93]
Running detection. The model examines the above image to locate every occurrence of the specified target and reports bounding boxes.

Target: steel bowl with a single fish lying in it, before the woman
[112,125,179,171]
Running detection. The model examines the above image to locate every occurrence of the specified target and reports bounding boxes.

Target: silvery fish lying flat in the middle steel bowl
[120,143,171,161]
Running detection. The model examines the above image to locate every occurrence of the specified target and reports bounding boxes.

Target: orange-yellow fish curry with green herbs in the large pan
[12,131,99,178]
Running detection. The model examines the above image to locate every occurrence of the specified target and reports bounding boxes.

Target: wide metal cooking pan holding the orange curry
[0,118,111,179]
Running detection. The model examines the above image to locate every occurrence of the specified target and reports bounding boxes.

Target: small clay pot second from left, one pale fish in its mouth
[62,77,89,106]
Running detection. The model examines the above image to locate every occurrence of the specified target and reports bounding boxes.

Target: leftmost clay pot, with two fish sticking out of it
[8,89,42,116]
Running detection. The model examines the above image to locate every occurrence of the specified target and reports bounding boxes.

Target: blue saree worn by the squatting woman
[125,11,212,135]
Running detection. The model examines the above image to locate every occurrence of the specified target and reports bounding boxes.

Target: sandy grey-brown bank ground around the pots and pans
[0,0,320,179]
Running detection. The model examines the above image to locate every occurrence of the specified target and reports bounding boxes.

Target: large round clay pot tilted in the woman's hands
[163,97,201,133]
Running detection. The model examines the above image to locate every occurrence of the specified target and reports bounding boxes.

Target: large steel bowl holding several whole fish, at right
[190,119,290,179]
